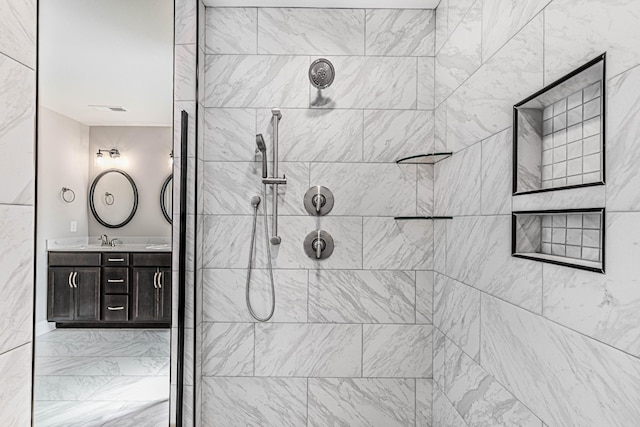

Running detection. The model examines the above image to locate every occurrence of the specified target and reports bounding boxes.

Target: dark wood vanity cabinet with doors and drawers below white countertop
[47,246,171,327]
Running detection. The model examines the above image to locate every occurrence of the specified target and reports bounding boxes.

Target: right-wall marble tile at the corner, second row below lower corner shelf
[433,274,480,359]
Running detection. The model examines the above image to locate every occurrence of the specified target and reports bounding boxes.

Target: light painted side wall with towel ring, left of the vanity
[36,107,89,333]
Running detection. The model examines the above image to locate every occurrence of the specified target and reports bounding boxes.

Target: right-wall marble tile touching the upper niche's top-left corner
[447,15,543,151]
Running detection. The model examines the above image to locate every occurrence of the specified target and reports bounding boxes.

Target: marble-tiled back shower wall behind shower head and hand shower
[201,8,435,426]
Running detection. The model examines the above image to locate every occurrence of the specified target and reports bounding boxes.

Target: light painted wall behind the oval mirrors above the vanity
[86,126,173,238]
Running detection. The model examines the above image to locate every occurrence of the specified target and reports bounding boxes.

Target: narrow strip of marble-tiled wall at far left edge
[0,0,37,426]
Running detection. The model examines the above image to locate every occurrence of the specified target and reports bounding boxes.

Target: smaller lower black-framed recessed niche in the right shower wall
[511,208,605,273]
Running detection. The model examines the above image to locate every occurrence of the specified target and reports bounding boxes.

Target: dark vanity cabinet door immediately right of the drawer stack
[131,267,158,322]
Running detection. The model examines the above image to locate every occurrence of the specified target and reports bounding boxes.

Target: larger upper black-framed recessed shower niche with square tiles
[513,54,606,195]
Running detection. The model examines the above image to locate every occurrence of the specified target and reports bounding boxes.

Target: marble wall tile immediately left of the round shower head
[205,55,309,108]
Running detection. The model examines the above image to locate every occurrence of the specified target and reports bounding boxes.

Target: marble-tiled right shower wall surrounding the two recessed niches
[433,0,640,427]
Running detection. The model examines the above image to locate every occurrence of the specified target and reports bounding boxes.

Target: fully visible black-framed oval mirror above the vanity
[89,169,138,228]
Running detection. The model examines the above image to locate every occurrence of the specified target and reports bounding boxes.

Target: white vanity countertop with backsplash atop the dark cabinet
[47,237,171,252]
